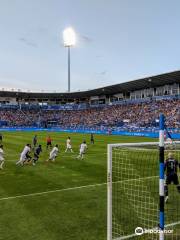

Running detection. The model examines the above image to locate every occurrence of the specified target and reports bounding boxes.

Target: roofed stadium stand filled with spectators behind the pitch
[0,71,180,131]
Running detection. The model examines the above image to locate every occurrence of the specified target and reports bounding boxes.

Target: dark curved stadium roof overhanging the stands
[0,71,180,99]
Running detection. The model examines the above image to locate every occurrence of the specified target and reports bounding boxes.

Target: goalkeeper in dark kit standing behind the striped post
[164,153,180,202]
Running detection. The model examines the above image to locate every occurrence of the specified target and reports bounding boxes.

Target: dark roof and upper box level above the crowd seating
[0,71,180,105]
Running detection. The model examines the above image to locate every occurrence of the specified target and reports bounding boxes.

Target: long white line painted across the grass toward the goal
[0,176,158,201]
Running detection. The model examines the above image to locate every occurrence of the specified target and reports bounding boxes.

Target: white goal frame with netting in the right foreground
[107,142,180,240]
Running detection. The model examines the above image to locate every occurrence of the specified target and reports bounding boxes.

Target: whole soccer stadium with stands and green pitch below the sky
[0,71,180,239]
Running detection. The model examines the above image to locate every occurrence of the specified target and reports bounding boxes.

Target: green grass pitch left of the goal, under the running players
[0,132,179,240]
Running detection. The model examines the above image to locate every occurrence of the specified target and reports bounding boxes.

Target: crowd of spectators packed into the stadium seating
[0,99,180,128]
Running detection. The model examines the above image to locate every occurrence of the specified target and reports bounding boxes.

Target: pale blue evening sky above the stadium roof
[0,0,180,92]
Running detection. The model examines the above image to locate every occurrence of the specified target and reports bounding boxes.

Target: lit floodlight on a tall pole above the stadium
[63,27,76,92]
